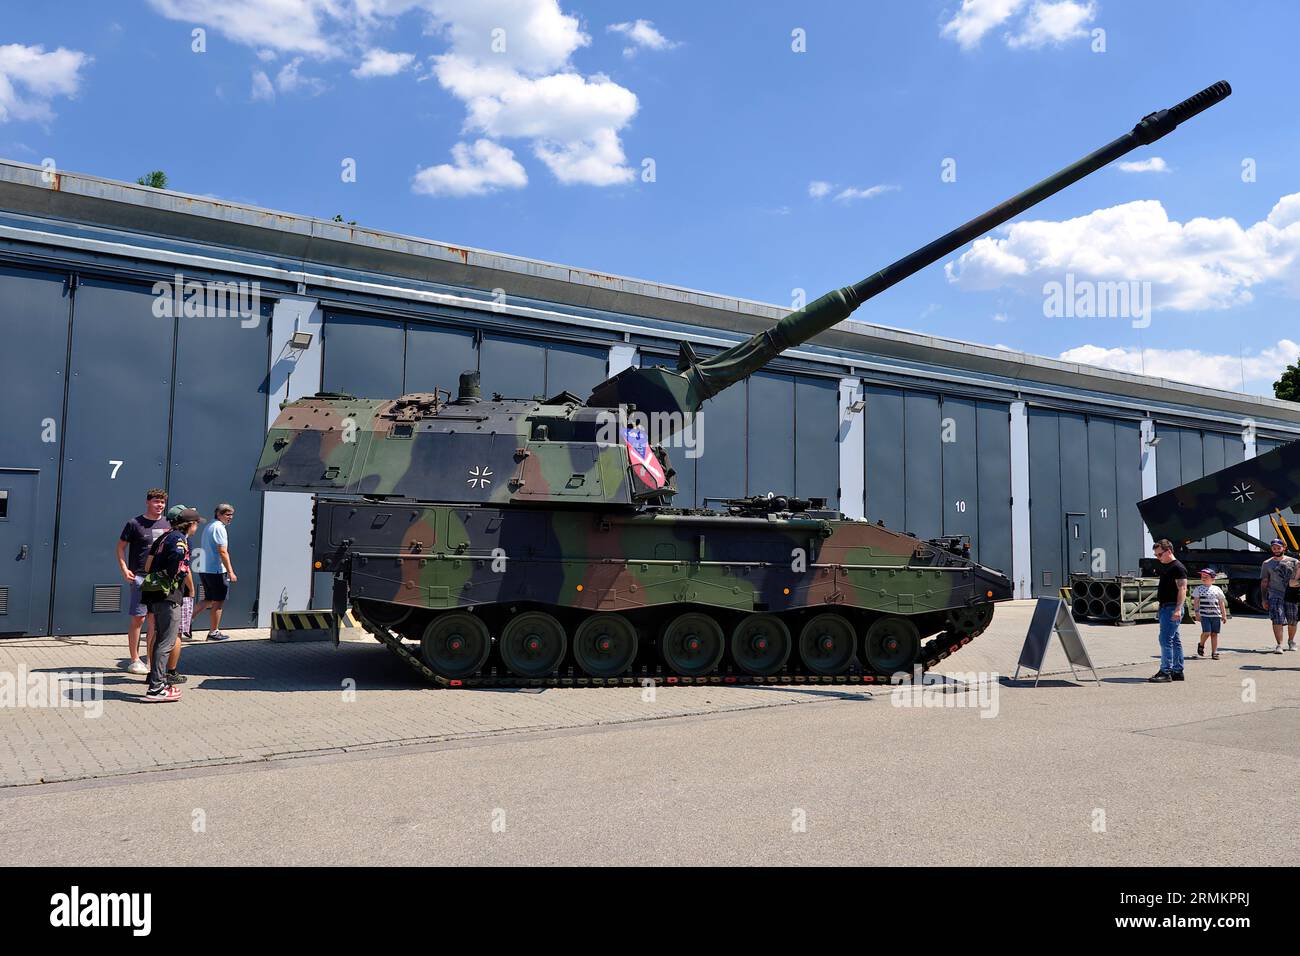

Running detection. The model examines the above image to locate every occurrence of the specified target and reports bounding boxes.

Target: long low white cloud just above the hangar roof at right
[1061,338,1300,390]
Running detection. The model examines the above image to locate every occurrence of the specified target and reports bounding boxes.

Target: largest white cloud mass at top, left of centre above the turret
[148,0,644,186]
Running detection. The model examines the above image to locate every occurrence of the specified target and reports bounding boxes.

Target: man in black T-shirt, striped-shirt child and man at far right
[1148,538,1300,684]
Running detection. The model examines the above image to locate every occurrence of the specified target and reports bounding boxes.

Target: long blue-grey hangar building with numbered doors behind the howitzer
[0,161,1300,635]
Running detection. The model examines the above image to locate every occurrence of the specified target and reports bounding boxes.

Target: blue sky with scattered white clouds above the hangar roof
[0,0,1300,394]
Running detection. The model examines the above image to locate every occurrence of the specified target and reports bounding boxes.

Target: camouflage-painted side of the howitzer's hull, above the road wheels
[315,498,1011,621]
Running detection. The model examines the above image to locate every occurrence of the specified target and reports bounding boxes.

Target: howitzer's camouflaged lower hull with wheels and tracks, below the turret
[313,497,1011,684]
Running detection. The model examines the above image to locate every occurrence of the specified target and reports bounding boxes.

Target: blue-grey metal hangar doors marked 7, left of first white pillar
[0,269,268,635]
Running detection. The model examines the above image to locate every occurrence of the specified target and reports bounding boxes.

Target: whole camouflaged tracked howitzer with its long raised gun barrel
[254,83,1230,687]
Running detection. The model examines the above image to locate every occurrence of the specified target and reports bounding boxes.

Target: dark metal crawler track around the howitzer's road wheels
[356,614,988,689]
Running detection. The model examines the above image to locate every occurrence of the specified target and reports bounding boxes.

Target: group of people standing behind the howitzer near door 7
[117,488,238,702]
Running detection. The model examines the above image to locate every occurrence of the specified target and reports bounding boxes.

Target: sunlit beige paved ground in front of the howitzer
[0,604,1300,865]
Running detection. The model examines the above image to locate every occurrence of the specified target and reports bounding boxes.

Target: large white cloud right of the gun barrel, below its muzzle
[944,193,1300,311]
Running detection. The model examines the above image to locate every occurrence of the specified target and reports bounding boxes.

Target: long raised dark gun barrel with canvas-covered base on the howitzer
[589,82,1232,412]
